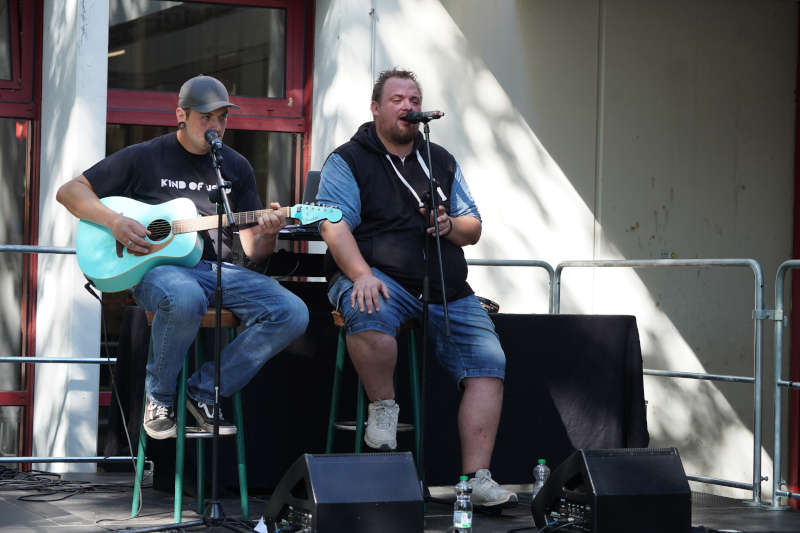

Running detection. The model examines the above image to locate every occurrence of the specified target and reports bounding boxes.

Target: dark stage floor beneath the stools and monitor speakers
[0,474,800,533]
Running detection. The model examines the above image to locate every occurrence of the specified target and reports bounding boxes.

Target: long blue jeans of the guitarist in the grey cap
[133,260,308,405]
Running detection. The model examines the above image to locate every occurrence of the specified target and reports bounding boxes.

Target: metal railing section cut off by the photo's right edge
[770,259,800,508]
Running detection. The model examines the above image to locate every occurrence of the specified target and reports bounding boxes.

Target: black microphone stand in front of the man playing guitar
[130,142,250,533]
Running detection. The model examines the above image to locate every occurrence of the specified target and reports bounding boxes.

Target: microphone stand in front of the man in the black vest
[417,117,452,501]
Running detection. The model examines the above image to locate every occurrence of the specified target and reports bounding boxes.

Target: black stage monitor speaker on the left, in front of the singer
[264,452,424,533]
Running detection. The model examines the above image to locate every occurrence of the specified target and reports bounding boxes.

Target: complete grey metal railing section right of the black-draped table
[553,259,768,503]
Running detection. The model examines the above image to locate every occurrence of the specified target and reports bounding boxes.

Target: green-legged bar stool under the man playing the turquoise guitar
[131,309,249,523]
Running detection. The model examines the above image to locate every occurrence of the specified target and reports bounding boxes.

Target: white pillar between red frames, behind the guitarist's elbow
[33,0,108,472]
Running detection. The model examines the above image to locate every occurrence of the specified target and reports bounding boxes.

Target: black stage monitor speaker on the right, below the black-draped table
[531,448,692,533]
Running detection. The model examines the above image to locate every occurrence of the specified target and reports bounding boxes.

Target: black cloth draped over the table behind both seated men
[105,290,649,490]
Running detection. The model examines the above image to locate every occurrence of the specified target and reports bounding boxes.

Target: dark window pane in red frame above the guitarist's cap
[108,0,286,98]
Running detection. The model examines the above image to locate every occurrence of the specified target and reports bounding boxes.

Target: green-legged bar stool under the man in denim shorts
[325,310,421,469]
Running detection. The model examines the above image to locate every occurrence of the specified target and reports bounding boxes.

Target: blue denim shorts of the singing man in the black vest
[328,268,506,384]
